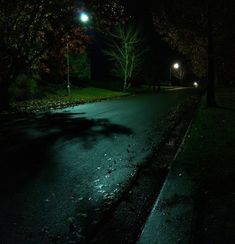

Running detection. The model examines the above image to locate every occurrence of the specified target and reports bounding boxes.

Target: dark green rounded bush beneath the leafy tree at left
[9,74,38,101]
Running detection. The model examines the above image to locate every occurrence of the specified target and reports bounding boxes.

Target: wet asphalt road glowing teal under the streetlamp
[0,89,194,244]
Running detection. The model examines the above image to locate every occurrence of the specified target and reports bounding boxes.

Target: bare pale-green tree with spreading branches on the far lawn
[104,25,144,91]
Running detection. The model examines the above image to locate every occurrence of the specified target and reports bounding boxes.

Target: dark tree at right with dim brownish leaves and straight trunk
[154,0,234,106]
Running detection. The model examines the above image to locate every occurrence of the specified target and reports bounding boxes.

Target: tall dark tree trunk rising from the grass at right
[207,3,216,107]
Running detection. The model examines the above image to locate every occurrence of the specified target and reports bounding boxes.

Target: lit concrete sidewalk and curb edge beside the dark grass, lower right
[137,123,195,244]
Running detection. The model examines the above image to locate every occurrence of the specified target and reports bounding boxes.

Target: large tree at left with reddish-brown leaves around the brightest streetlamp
[0,0,129,108]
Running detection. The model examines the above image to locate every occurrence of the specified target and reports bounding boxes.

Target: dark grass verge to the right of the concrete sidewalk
[177,89,235,243]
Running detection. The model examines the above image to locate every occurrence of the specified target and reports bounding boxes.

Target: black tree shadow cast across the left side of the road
[0,113,133,191]
